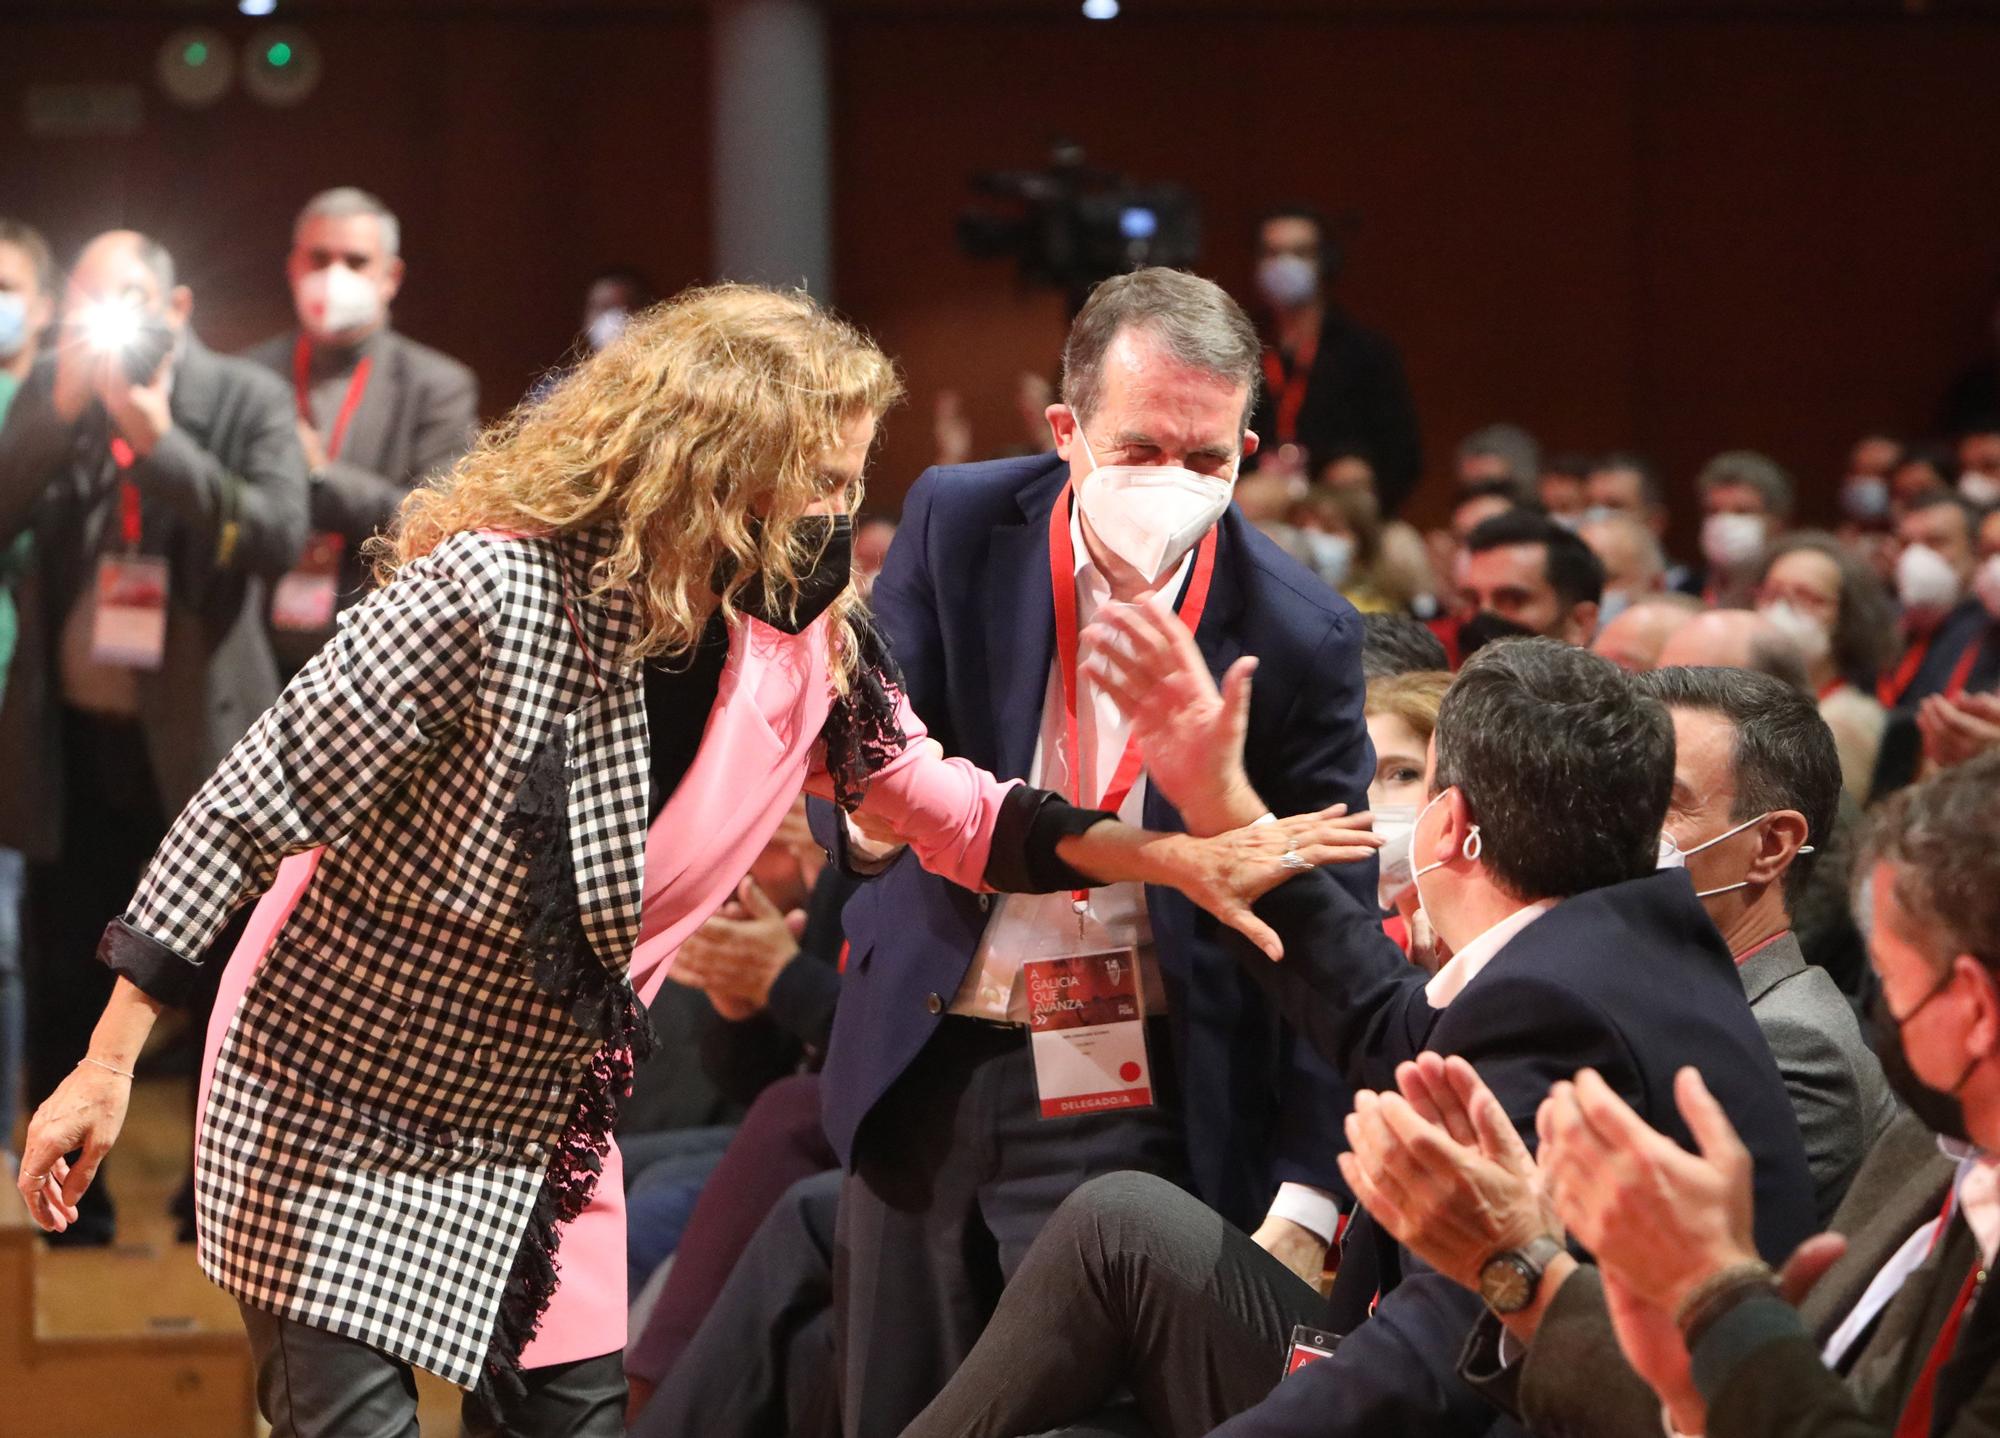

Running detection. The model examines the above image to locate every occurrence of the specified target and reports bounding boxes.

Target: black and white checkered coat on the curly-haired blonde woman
[126,530,648,1386]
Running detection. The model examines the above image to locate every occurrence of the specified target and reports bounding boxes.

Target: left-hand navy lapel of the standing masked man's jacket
[978,462,1070,778]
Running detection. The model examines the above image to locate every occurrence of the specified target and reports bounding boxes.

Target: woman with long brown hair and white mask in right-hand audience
[1756,530,1898,804]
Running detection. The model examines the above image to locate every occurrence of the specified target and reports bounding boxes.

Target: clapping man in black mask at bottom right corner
[1540,758,2000,1438]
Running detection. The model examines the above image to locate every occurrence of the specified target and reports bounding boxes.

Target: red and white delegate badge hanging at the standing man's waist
[1020,948,1152,1118]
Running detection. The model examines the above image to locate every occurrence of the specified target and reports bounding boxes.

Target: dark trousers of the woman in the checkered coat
[238,1304,626,1438]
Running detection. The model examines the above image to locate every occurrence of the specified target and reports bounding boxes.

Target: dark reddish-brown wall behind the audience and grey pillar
[0,0,2000,540]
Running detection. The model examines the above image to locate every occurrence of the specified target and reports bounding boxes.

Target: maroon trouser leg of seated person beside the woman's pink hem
[626,1074,838,1384]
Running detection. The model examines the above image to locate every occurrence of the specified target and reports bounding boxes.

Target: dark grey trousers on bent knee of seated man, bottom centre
[906,1174,1328,1438]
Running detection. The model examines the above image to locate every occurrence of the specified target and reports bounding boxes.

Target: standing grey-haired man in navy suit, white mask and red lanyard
[824,270,1376,1438]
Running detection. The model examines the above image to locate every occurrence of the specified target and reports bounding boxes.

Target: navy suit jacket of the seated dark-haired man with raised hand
[1216,868,1818,1438]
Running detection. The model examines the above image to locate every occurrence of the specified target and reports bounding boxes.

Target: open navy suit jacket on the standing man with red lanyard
[822,454,1376,1224]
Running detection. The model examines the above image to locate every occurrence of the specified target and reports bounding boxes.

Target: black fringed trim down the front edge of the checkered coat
[478,724,654,1414]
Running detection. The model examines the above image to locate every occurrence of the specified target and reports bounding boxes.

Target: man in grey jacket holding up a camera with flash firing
[0,230,306,1244]
